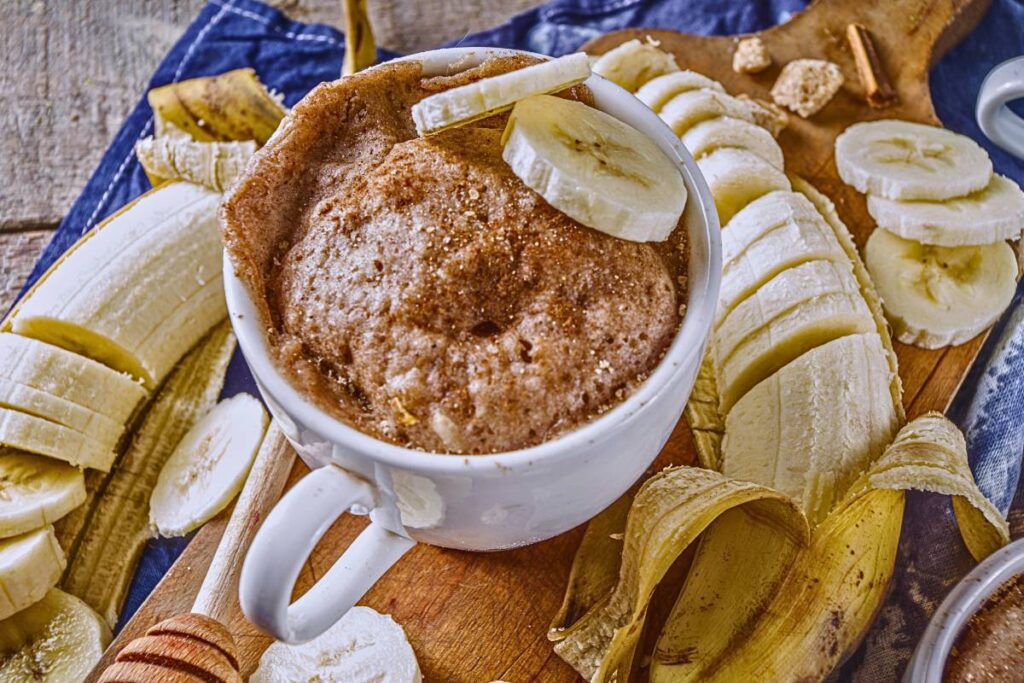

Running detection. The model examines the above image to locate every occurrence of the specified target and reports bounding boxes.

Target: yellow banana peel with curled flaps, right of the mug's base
[549,413,1009,682]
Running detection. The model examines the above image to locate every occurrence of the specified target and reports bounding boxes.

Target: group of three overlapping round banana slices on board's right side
[836,120,1024,348]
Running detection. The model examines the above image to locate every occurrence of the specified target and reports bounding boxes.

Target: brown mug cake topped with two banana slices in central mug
[221,55,687,454]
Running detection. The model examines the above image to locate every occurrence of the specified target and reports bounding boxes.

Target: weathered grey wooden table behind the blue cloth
[0,0,539,313]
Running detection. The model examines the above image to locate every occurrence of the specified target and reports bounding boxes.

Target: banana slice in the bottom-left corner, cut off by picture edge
[0,588,111,683]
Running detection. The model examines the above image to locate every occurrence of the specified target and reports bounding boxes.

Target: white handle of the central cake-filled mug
[239,465,416,643]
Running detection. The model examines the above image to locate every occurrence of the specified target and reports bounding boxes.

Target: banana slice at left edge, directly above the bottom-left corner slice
[0,526,66,620]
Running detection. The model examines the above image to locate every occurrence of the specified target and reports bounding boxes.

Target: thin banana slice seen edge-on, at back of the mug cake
[413,52,590,135]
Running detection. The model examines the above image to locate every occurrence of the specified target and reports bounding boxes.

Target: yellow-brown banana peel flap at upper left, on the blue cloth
[146,69,287,145]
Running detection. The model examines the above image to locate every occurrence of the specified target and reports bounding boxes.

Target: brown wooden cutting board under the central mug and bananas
[88,0,989,683]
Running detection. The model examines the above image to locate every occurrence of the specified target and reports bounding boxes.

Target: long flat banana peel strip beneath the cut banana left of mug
[60,321,236,627]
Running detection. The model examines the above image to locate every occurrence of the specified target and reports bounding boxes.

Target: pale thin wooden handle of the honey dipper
[193,421,295,624]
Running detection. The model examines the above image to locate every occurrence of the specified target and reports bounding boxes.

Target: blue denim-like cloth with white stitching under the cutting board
[27,0,1024,681]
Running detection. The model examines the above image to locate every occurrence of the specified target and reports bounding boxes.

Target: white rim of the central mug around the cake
[223,47,721,474]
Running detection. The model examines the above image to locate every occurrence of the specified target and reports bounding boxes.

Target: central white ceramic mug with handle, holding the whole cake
[230,48,721,643]
